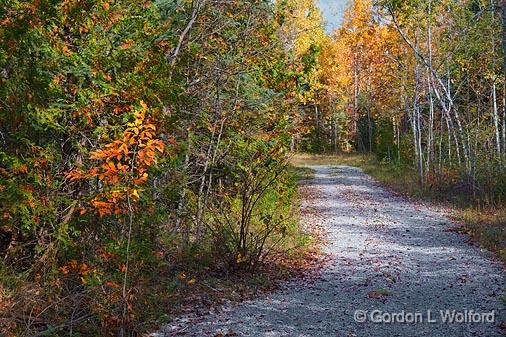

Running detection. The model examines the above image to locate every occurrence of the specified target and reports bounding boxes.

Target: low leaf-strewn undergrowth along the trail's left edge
[0,167,318,337]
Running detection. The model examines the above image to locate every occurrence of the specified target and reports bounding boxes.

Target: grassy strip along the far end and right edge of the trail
[292,154,506,263]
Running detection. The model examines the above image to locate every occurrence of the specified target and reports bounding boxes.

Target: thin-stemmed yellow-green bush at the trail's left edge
[205,135,295,270]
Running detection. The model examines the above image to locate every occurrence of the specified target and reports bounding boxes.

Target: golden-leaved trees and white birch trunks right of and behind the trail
[299,0,506,202]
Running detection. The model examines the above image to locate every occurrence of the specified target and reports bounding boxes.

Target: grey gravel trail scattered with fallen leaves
[157,166,505,337]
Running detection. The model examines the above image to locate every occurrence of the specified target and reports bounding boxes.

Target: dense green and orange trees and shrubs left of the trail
[0,0,308,335]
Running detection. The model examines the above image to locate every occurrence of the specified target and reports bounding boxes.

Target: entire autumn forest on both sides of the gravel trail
[0,0,506,336]
